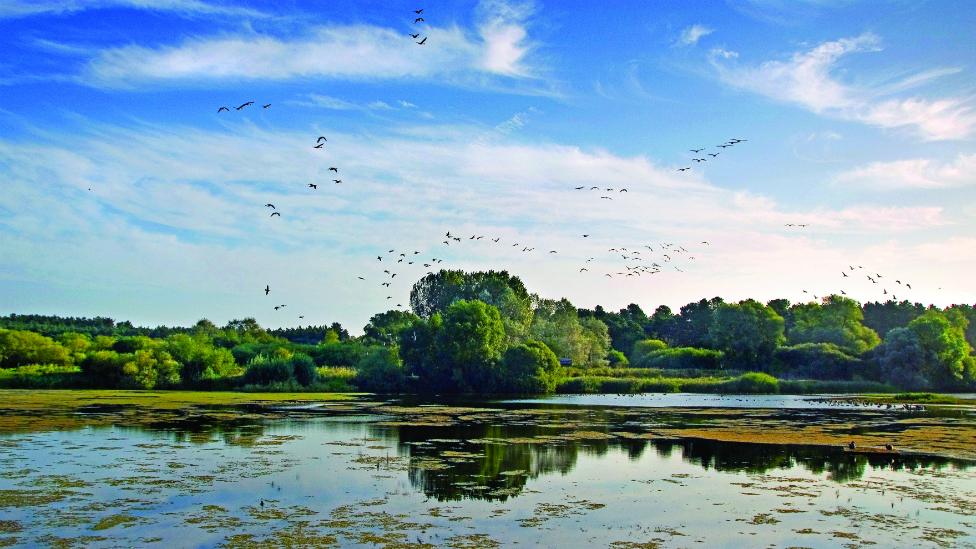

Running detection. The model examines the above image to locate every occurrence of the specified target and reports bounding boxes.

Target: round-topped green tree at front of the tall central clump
[435,300,505,393]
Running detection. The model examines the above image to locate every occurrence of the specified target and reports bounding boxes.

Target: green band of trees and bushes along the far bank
[0,271,976,393]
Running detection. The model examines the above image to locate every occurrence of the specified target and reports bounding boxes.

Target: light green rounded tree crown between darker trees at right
[790,295,881,354]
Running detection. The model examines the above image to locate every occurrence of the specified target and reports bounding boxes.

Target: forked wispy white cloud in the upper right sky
[711,33,976,141]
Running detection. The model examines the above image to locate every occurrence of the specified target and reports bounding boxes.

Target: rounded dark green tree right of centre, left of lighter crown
[709,299,786,369]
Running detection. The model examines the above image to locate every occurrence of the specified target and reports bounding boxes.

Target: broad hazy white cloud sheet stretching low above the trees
[0,118,976,329]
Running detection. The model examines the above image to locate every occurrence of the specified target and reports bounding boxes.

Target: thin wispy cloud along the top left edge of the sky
[0,0,267,18]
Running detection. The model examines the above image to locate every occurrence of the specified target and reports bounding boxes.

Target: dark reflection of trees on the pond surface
[388,425,965,501]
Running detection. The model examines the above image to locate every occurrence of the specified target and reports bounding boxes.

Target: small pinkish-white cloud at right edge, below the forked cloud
[834,154,976,189]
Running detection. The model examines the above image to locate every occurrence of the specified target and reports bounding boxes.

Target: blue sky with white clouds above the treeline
[0,0,976,333]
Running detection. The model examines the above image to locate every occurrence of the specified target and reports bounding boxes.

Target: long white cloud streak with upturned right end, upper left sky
[80,2,533,88]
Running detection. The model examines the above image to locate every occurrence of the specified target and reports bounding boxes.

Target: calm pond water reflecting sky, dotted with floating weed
[0,395,976,547]
